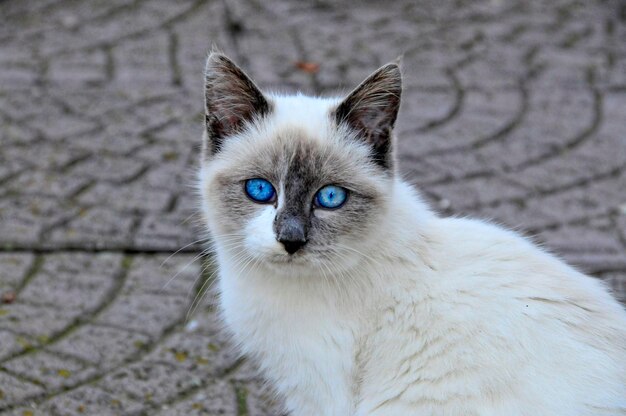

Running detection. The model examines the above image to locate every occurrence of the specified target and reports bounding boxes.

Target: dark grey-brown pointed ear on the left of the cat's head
[204,52,270,157]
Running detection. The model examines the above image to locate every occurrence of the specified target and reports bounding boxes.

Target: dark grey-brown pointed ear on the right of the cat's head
[335,62,402,169]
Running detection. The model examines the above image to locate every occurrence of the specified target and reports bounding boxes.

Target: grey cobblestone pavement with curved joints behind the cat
[0,0,626,416]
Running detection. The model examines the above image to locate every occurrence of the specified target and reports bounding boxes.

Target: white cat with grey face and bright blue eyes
[199,52,626,416]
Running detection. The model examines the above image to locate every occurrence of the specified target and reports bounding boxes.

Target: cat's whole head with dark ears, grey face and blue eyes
[200,53,402,274]
